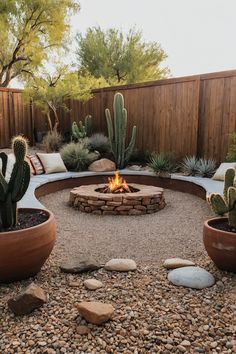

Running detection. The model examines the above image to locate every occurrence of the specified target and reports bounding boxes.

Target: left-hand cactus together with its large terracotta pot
[0,136,56,282]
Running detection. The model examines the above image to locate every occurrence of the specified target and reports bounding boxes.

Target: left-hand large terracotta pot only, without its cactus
[0,209,56,283]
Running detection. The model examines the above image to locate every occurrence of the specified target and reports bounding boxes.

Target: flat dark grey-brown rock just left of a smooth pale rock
[60,257,101,274]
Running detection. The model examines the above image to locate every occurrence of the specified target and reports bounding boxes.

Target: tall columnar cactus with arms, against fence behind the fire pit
[105,93,137,168]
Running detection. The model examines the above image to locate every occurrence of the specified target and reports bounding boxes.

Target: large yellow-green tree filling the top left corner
[0,0,79,87]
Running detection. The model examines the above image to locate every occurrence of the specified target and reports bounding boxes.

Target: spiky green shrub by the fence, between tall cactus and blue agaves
[148,151,176,173]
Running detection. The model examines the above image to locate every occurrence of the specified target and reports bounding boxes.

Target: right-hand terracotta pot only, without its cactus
[203,217,236,273]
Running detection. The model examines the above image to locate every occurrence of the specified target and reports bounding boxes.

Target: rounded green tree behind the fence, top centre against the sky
[77,27,169,85]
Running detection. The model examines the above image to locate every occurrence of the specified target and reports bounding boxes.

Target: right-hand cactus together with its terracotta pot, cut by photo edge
[203,168,236,273]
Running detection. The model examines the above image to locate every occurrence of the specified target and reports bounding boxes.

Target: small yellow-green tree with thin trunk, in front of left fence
[24,64,105,132]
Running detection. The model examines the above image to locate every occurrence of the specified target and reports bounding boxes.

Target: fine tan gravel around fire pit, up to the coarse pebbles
[41,189,212,264]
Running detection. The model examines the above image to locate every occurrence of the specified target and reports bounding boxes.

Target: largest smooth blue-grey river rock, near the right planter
[168,267,215,289]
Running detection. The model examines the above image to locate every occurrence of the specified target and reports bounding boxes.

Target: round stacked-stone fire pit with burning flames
[69,172,165,215]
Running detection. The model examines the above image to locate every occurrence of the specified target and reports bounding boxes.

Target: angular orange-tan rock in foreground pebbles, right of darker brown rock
[77,301,115,325]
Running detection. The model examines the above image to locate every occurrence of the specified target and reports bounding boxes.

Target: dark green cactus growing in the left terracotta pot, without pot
[0,136,30,229]
